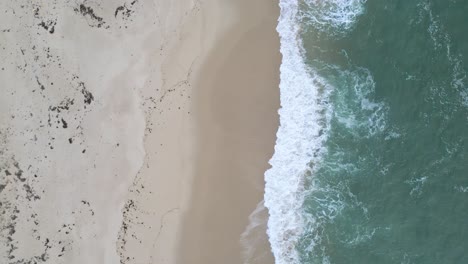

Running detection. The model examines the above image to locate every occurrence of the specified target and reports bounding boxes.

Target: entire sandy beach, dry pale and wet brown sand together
[0,0,280,264]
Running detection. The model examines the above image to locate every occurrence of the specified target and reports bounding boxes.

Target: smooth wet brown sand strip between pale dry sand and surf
[177,1,281,264]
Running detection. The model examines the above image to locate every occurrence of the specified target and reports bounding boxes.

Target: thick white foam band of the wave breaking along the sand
[265,0,330,264]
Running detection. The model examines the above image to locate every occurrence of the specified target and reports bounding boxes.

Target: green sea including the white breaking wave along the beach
[265,0,468,264]
